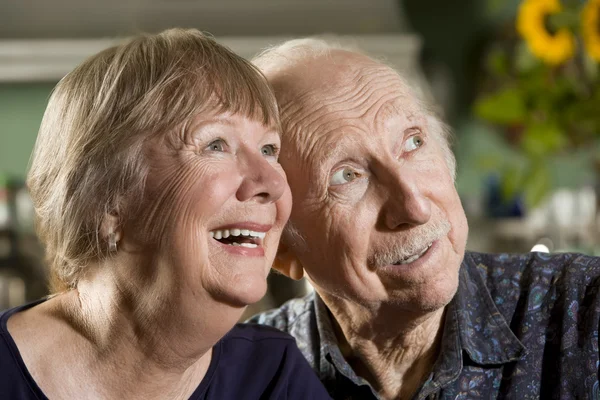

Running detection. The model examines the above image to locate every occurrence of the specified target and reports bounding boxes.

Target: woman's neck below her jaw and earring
[64,255,244,370]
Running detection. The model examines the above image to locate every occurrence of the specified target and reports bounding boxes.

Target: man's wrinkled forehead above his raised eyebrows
[267,50,423,160]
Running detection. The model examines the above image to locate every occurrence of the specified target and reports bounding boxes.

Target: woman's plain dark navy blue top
[0,301,330,400]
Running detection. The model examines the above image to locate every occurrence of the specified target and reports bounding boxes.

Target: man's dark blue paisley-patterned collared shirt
[250,252,600,399]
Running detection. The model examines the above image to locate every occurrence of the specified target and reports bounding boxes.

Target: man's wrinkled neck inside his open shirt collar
[321,294,444,399]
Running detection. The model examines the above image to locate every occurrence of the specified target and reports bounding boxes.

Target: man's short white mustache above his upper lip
[368,217,451,268]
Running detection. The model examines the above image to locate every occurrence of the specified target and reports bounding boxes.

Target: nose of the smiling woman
[236,154,287,203]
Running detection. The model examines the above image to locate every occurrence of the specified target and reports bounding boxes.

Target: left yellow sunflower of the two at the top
[517,0,575,65]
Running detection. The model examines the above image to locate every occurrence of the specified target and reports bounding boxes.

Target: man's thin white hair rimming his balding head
[252,37,456,247]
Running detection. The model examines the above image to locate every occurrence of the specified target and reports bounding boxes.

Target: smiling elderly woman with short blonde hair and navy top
[0,30,327,400]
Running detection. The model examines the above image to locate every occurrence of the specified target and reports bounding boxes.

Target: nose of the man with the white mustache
[383,169,431,230]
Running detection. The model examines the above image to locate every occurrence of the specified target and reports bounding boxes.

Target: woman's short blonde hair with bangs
[27,29,279,292]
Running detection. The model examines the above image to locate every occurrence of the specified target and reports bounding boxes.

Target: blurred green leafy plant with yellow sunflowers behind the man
[474,0,600,207]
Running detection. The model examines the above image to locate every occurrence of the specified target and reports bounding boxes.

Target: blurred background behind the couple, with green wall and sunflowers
[0,0,600,313]
